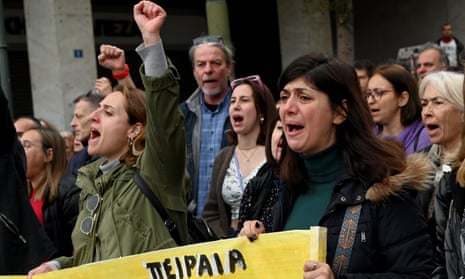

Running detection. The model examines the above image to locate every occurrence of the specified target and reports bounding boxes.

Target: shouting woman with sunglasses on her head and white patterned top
[203,75,277,238]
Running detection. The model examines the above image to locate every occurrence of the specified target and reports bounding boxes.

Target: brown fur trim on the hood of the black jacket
[365,153,435,202]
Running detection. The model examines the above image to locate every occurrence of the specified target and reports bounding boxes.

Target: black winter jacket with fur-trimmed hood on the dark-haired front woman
[273,154,434,279]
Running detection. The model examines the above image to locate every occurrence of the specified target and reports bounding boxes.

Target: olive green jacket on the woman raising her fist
[56,62,190,268]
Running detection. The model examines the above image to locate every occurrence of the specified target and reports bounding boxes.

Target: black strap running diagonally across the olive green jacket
[134,168,182,245]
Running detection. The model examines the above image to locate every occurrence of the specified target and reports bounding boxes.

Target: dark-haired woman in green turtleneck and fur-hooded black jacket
[240,53,434,279]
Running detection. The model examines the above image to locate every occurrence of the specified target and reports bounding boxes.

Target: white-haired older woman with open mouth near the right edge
[418,71,464,252]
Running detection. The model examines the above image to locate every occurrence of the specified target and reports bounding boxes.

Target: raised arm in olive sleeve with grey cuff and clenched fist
[134,1,189,243]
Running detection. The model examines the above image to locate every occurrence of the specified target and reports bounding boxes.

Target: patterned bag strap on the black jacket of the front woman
[332,204,362,277]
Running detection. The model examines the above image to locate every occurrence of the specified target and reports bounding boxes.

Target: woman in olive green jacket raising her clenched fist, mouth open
[28,1,189,278]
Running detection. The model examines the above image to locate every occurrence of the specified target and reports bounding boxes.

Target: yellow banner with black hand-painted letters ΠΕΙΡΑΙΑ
[0,230,310,279]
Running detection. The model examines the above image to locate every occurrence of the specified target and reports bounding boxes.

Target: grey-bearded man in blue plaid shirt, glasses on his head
[180,36,234,216]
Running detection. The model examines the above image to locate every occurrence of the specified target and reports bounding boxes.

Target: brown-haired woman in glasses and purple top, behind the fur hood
[365,64,431,155]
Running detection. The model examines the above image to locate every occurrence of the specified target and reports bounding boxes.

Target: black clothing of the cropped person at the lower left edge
[0,89,54,275]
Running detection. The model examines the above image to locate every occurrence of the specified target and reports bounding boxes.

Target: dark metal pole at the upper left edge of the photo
[0,0,14,118]
